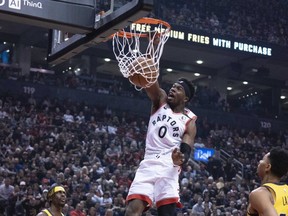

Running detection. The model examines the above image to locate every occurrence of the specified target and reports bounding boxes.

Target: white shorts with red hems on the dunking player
[126,152,181,208]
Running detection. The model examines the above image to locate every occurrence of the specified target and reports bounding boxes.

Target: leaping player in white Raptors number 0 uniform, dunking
[125,78,196,216]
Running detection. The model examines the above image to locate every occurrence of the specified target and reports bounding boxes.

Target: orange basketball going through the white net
[128,57,158,88]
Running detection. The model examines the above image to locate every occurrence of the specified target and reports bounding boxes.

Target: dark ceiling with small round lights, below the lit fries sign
[0,15,288,109]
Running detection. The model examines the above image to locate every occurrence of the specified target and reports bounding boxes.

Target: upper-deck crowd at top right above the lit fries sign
[155,0,288,46]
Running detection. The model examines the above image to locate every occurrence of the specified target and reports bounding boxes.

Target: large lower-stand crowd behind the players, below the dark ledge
[0,90,288,216]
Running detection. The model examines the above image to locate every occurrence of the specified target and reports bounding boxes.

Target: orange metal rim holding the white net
[109,17,171,38]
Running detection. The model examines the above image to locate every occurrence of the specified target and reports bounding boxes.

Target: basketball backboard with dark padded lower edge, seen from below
[47,0,154,66]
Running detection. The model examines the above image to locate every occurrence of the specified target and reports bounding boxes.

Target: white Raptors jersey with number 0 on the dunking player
[146,104,197,154]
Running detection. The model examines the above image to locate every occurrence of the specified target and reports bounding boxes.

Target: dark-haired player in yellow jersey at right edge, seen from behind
[247,147,288,216]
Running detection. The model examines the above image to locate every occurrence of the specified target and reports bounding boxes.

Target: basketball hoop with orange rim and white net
[112,17,171,90]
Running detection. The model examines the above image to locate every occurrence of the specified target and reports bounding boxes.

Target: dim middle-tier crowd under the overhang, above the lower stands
[0,66,275,118]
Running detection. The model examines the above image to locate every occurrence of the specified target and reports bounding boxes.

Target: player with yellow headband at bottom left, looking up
[37,185,66,216]
